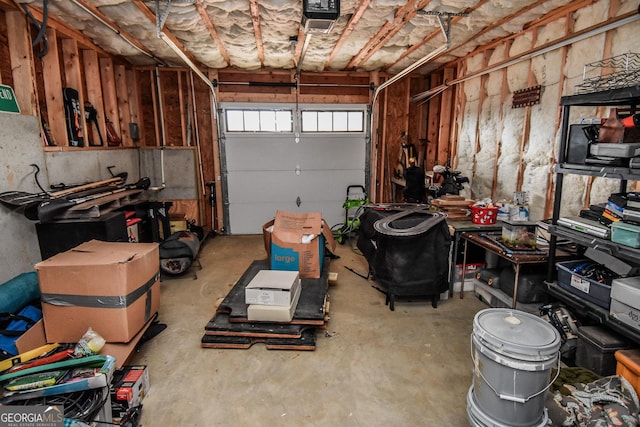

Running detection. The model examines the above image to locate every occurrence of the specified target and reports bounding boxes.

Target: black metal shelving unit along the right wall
[547,85,640,343]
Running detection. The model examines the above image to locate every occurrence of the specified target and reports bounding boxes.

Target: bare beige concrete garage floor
[130,235,487,427]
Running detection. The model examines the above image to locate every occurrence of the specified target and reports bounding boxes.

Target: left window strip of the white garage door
[226,110,293,132]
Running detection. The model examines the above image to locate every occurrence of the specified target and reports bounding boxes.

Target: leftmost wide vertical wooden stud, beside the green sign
[5,11,38,116]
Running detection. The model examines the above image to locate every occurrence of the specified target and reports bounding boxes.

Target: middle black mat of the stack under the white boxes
[204,313,314,338]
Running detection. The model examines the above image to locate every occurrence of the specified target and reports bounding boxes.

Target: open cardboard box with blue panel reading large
[263,211,336,279]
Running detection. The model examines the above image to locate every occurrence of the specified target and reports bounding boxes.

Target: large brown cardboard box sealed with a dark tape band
[36,240,160,343]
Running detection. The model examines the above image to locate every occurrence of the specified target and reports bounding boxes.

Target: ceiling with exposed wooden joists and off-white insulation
[11,0,600,74]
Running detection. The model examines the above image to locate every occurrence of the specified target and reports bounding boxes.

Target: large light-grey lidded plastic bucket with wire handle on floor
[471,308,561,427]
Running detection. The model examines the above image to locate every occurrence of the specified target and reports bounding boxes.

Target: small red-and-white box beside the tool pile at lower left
[111,365,151,412]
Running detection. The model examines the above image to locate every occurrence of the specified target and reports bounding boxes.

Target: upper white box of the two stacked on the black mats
[244,270,300,307]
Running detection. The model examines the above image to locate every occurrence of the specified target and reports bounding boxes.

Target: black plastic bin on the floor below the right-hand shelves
[576,326,629,376]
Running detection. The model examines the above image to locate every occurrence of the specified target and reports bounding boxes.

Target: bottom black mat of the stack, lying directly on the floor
[200,328,316,351]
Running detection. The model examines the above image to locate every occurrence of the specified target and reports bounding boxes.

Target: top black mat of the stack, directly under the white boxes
[217,258,329,325]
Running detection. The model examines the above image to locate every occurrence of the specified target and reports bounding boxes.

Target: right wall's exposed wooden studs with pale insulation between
[429,0,640,219]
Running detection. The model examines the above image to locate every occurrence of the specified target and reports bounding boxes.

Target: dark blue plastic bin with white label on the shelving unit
[556,259,611,309]
